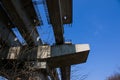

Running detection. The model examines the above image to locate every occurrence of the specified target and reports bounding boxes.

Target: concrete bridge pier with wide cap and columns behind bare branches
[0,44,90,80]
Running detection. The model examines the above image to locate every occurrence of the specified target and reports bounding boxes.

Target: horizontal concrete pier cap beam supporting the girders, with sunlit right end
[0,44,90,68]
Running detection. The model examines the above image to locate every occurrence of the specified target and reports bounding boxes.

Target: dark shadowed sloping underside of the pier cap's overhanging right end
[47,50,89,67]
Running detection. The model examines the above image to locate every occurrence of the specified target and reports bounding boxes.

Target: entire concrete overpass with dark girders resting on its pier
[0,0,90,80]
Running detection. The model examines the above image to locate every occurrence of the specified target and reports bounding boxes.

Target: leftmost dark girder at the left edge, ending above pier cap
[0,5,20,46]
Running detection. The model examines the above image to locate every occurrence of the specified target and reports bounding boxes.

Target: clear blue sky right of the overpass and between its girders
[0,0,120,80]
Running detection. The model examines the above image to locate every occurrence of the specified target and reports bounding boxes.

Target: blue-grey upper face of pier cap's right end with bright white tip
[51,44,90,56]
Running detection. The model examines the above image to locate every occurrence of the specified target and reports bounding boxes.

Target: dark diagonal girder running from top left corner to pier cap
[1,0,41,45]
